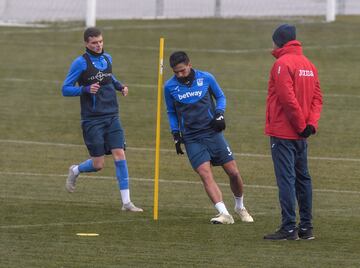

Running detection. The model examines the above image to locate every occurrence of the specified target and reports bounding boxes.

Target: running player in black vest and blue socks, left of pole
[62,27,143,212]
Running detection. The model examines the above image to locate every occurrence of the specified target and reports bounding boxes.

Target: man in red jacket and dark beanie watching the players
[264,24,322,240]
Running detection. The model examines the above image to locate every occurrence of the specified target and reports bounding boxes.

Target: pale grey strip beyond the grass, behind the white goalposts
[0,0,360,22]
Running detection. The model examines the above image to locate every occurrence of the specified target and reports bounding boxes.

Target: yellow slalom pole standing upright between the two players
[154,37,164,220]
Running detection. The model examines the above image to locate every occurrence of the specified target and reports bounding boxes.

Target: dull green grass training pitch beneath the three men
[0,17,360,268]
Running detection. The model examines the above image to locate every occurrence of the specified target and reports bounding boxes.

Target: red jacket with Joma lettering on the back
[265,40,322,139]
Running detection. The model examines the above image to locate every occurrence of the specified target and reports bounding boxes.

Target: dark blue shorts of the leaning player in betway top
[185,133,234,169]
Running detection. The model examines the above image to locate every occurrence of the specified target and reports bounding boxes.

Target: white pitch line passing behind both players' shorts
[0,139,360,162]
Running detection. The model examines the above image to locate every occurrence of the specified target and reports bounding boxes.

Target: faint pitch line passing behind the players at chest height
[0,78,360,98]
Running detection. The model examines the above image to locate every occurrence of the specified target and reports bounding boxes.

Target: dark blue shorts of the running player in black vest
[81,117,125,157]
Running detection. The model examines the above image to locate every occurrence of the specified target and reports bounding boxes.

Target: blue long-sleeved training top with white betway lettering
[164,69,226,141]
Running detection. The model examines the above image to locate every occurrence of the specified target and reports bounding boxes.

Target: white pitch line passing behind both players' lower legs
[0,171,360,194]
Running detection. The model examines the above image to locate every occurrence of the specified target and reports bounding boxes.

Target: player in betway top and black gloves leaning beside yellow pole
[164,51,254,224]
